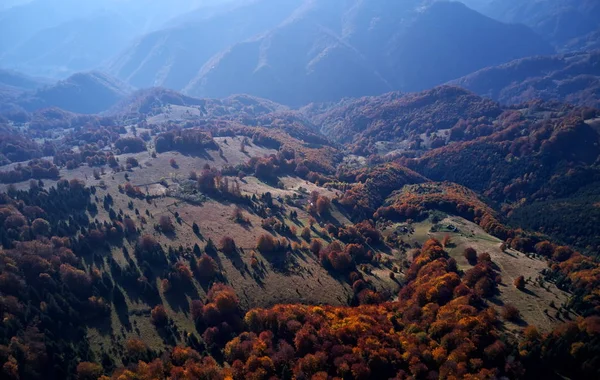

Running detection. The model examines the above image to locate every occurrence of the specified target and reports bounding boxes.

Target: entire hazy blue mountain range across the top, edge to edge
[0,0,600,113]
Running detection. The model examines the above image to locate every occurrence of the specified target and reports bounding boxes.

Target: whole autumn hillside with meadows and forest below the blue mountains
[0,87,600,379]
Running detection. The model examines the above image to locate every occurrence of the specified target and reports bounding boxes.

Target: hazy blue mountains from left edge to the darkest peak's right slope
[0,0,554,106]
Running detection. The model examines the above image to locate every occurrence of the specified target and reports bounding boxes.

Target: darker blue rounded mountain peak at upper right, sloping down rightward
[380,2,553,91]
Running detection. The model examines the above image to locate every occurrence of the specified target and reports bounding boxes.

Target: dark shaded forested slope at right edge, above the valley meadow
[404,110,600,202]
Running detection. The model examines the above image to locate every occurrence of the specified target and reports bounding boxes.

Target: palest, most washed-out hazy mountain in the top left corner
[0,0,242,78]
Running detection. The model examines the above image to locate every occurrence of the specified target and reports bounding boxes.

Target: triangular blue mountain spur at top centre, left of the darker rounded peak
[186,2,392,105]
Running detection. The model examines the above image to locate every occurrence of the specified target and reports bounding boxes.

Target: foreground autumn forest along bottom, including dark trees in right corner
[108,240,600,379]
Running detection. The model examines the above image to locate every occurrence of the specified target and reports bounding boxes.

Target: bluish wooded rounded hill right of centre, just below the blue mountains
[311,86,502,148]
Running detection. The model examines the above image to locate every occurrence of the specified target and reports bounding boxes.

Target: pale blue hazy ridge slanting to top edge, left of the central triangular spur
[108,0,302,89]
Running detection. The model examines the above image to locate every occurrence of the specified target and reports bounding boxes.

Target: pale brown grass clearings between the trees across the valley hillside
[0,132,568,357]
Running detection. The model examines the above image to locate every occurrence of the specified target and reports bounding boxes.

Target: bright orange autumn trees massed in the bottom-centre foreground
[123,240,522,379]
